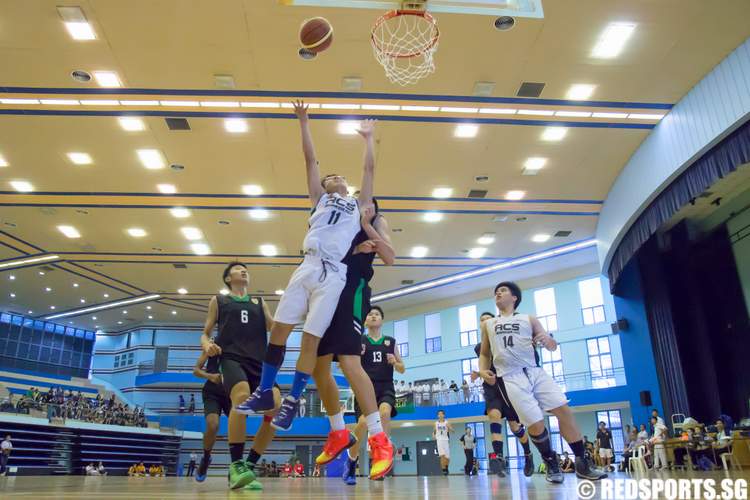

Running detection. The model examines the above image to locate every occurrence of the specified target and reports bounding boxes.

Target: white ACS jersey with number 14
[485,313,538,377]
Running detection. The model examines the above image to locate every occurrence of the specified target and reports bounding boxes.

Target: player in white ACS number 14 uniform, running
[479,281,607,483]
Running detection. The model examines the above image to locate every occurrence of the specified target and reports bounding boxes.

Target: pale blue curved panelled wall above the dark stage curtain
[596,39,750,272]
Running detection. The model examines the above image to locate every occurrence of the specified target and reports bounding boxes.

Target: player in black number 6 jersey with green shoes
[201,262,281,489]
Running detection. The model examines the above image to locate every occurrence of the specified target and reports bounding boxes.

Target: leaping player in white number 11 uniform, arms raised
[237,101,383,433]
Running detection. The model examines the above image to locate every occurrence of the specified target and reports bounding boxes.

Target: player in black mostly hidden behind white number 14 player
[471,312,534,477]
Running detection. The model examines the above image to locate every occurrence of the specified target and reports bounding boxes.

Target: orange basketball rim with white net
[370,10,440,85]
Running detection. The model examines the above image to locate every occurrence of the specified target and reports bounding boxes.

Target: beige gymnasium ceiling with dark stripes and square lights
[0,0,750,331]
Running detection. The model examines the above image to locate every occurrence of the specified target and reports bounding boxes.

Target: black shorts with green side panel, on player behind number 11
[318,278,372,361]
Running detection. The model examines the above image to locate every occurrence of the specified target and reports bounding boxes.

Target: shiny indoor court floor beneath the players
[0,470,750,500]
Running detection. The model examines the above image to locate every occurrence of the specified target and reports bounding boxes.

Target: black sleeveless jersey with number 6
[215,295,267,363]
